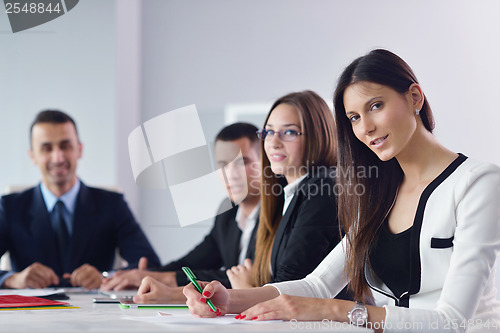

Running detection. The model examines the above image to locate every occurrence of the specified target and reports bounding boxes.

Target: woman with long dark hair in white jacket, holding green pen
[184,50,500,332]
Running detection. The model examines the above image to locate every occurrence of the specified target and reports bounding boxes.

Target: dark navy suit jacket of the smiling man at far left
[0,183,159,278]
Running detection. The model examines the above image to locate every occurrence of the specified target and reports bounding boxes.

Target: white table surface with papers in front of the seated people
[0,294,371,333]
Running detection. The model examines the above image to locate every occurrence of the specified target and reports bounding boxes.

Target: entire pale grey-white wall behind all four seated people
[0,0,500,290]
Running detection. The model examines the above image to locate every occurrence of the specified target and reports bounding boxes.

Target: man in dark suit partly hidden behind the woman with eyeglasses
[101,123,260,296]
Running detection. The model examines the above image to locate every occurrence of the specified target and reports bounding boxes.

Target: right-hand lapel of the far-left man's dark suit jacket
[67,183,98,272]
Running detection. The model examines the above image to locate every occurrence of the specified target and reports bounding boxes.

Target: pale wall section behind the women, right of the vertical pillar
[136,0,500,264]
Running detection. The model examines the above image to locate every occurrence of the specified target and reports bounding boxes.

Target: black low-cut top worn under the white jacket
[370,219,413,297]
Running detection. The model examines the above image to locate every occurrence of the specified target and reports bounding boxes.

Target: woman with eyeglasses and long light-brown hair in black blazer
[227,91,344,297]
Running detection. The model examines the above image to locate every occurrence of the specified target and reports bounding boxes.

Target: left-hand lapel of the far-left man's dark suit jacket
[27,186,63,275]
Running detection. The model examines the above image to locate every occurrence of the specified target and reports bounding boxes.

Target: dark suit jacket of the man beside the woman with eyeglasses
[157,203,258,288]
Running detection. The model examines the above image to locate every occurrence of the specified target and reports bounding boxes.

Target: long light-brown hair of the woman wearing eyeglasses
[252,90,337,286]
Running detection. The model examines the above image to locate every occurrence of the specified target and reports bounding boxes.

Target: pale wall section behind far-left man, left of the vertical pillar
[0,1,118,192]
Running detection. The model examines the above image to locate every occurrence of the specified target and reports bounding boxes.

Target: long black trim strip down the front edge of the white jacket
[408,153,467,295]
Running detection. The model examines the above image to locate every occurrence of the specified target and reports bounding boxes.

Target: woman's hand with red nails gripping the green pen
[182,281,229,317]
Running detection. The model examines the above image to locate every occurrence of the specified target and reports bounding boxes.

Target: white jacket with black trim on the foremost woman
[272,154,500,333]
